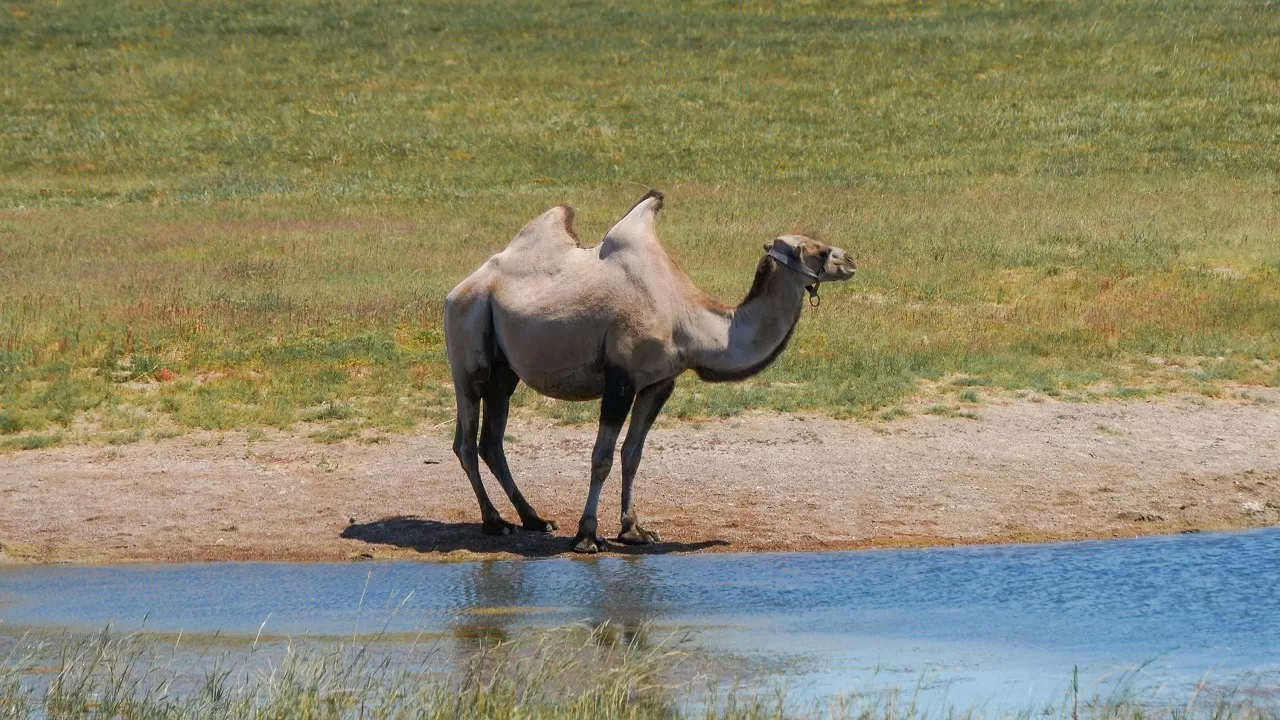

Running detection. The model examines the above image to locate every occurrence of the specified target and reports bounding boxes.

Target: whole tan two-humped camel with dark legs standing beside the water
[444,191,855,552]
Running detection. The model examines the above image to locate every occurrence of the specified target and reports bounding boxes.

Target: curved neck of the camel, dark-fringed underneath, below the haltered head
[691,256,804,382]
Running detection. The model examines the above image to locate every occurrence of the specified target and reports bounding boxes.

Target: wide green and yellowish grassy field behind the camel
[0,0,1280,448]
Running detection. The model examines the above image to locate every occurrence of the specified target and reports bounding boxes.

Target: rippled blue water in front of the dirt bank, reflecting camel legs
[0,529,1280,707]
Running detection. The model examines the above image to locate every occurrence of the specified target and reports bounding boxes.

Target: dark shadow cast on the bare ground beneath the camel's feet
[342,515,730,557]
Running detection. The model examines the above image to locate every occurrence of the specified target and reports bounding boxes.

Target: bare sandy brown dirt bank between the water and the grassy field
[0,391,1280,562]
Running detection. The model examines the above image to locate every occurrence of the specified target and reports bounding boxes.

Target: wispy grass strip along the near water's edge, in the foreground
[0,623,1277,720]
